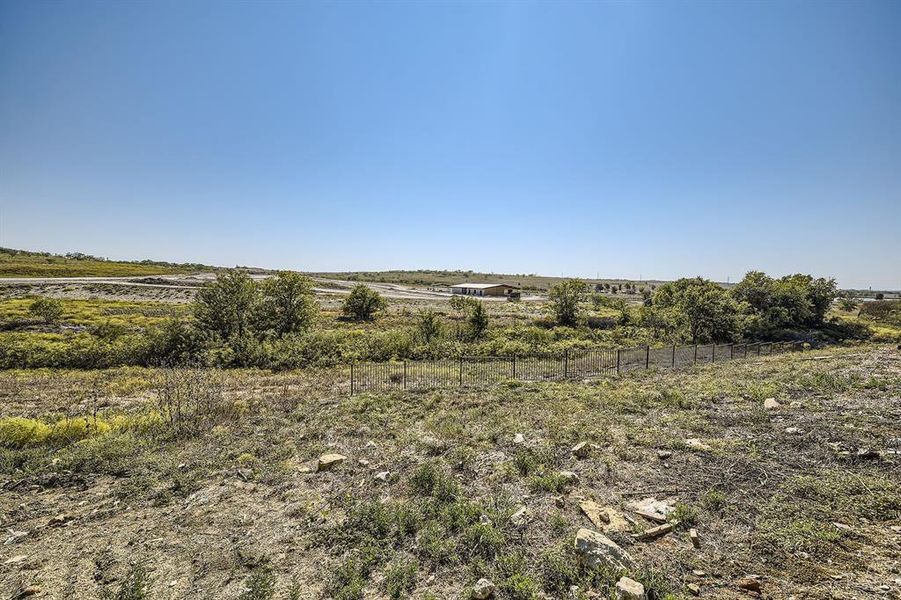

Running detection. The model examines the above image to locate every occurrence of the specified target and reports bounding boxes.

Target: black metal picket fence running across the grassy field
[350,342,803,395]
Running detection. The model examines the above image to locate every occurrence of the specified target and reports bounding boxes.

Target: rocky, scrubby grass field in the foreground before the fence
[0,345,901,599]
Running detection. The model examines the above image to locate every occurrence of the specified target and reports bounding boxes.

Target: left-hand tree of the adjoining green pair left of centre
[194,269,259,341]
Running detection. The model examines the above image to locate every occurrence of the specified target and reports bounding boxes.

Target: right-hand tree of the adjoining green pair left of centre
[255,271,319,337]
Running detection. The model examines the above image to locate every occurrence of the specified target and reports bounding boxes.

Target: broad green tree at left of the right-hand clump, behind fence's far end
[654,277,740,344]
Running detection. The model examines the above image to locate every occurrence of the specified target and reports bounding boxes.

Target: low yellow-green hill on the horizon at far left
[0,248,216,277]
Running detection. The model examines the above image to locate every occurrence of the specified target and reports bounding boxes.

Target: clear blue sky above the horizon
[0,0,901,288]
